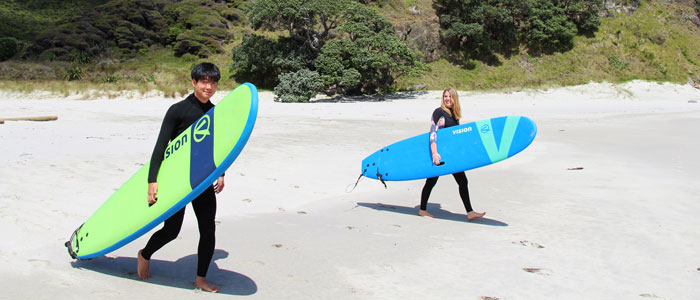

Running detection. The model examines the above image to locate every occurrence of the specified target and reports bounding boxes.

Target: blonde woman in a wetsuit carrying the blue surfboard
[418,88,486,221]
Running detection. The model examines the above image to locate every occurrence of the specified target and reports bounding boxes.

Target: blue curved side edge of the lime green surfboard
[78,82,258,259]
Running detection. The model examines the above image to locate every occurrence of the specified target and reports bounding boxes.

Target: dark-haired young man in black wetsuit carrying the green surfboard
[137,63,224,293]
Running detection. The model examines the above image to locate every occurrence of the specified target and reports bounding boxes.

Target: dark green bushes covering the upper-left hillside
[15,0,241,61]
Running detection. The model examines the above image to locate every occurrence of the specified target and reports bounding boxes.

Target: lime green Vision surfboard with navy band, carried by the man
[65,83,258,259]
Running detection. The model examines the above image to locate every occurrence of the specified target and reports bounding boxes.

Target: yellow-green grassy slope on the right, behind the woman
[399,1,700,90]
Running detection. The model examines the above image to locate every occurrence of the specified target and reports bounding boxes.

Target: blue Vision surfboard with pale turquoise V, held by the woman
[362,116,537,181]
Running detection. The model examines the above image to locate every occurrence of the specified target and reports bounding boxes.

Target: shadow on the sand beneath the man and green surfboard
[71,249,258,296]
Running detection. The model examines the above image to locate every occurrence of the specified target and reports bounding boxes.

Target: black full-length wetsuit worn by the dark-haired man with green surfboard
[141,94,216,277]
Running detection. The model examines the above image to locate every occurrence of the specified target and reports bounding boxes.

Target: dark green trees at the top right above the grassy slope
[433,0,602,62]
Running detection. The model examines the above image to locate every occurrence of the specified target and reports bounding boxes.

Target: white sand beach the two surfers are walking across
[0,81,700,300]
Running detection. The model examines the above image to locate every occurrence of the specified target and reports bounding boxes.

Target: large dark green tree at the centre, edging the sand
[232,0,421,101]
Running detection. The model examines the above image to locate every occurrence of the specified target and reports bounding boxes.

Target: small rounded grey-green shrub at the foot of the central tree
[275,69,323,102]
